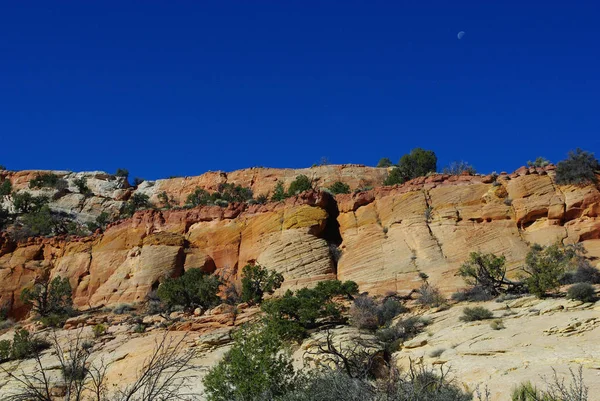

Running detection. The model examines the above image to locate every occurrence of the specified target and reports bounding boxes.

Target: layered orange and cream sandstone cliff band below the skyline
[0,166,600,317]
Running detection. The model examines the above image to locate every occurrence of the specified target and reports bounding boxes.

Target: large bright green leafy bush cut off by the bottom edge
[203,324,296,401]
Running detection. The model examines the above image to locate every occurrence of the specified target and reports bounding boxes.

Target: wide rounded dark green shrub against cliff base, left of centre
[157,268,221,309]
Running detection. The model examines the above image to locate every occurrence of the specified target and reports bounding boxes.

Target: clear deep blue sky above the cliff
[0,0,600,179]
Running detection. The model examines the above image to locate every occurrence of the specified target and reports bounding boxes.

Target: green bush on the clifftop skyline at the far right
[556,148,600,185]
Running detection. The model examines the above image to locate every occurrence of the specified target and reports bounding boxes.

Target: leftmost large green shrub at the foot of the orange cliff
[21,275,73,317]
